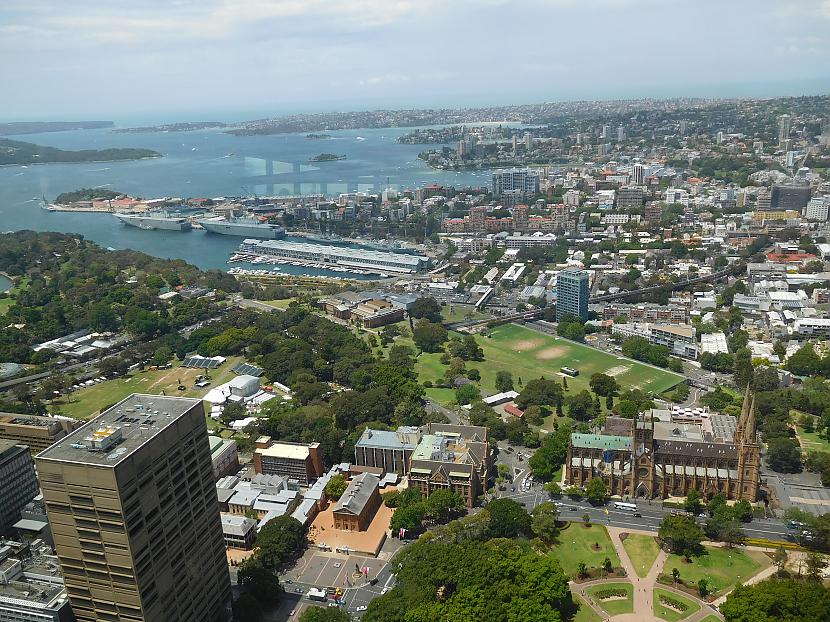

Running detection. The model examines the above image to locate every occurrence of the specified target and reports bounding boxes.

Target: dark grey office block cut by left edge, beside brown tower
[0,440,38,540]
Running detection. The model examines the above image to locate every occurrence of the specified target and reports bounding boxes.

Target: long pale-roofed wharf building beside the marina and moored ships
[239,239,430,274]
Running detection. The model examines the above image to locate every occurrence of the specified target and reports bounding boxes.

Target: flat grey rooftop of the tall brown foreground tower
[38,393,201,467]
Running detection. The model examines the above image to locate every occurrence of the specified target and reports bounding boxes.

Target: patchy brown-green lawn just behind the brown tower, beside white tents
[50,356,241,419]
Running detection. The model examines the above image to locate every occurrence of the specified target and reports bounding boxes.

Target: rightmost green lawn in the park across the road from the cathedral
[663,546,771,593]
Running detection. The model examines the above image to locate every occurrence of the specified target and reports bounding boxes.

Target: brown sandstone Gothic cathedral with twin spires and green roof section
[565,387,761,502]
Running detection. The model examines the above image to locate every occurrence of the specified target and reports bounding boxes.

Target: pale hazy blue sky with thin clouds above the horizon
[0,0,830,121]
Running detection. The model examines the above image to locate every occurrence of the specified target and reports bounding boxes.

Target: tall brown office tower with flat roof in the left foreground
[36,394,231,622]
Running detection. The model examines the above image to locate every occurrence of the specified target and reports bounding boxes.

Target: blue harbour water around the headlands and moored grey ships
[0,129,490,274]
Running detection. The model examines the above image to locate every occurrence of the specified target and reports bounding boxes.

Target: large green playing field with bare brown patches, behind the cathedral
[417,324,683,402]
